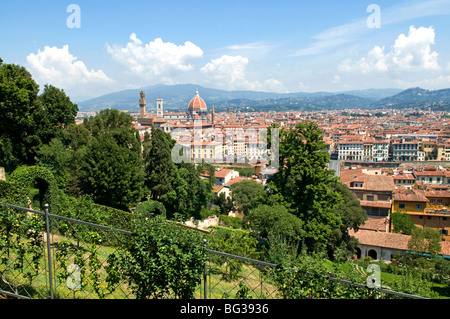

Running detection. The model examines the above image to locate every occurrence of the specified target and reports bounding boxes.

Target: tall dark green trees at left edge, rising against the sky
[0,62,78,172]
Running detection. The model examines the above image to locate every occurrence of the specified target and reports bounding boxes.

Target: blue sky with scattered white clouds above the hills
[0,0,450,101]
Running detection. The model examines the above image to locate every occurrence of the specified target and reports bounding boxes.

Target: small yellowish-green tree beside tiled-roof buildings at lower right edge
[408,227,442,256]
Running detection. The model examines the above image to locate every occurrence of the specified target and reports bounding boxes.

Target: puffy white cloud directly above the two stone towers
[107,33,203,84]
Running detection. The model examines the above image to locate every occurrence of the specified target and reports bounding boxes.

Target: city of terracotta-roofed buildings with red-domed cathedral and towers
[87,91,450,261]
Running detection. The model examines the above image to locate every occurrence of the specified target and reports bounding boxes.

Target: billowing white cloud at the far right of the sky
[339,26,440,73]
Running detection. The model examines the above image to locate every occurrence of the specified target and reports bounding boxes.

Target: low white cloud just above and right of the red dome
[200,55,287,92]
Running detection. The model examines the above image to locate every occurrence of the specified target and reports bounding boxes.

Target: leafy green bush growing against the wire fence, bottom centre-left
[111,212,205,299]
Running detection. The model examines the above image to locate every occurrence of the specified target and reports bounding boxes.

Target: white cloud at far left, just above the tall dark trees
[27,45,113,95]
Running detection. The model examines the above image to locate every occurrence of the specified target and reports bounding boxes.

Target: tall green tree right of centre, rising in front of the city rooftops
[267,122,342,251]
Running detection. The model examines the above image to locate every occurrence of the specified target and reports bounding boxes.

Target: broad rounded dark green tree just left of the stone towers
[75,110,145,209]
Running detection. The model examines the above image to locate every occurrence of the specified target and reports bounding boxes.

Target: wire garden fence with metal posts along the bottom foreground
[0,203,425,299]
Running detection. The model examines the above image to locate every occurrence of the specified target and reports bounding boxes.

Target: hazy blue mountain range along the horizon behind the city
[77,84,450,112]
